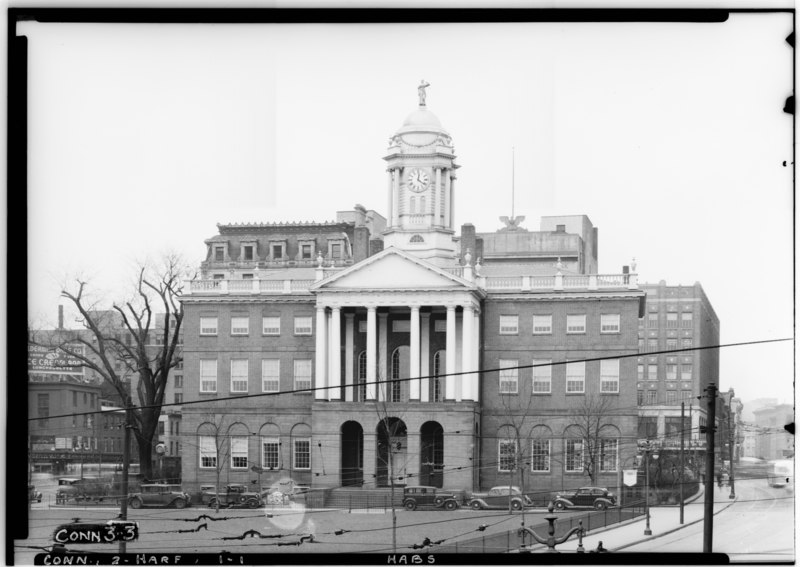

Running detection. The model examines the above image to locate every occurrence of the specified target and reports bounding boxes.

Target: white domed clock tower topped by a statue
[383,81,459,267]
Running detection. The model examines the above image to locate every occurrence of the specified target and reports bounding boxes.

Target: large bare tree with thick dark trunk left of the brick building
[31,254,188,479]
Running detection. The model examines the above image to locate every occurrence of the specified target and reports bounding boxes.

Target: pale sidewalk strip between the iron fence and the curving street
[530,486,736,553]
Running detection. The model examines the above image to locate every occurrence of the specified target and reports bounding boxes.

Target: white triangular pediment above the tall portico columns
[311,248,474,290]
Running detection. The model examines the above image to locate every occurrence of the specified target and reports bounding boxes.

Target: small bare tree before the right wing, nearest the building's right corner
[564,394,619,484]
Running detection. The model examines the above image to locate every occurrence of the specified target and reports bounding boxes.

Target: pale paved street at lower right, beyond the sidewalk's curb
[624,479,795,562]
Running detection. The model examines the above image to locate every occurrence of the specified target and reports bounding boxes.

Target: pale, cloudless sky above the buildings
[18,14,794,401]
